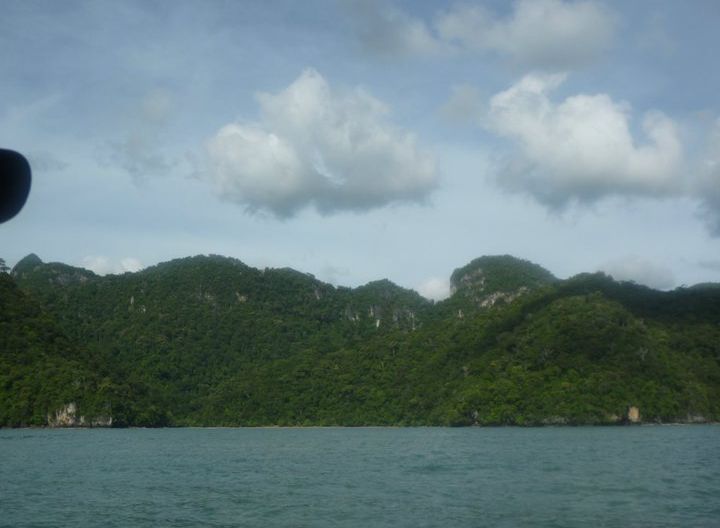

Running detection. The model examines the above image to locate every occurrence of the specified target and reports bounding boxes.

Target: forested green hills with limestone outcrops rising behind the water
[0,255,720,426]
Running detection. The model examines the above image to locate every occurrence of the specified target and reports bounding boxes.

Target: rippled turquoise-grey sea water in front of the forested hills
[0,425,720,527]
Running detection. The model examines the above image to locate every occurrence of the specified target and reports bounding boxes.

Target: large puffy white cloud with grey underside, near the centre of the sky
[205,69,436,217]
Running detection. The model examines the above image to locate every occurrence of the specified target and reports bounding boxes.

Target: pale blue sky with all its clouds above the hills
[0,0,720,299]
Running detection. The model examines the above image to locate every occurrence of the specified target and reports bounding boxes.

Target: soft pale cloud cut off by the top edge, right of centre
[437,0,616,70]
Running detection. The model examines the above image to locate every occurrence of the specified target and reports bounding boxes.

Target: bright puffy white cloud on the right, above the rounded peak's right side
[485,74,683,208]
